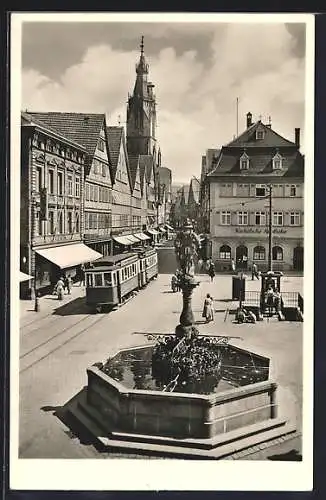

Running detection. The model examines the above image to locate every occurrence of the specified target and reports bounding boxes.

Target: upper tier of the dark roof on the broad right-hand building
[226,120,295,148]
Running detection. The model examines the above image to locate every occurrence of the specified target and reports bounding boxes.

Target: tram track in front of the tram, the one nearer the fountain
[19,314,106,373]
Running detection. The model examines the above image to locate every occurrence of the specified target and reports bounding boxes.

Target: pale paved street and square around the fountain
[19,274,303,458]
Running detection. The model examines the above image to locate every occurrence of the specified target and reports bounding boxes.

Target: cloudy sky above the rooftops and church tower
[22,22,305,182]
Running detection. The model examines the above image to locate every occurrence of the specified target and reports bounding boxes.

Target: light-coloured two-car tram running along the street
[85,248,158,312]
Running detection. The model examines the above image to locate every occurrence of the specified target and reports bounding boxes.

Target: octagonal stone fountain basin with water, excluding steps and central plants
[85,344,277,439]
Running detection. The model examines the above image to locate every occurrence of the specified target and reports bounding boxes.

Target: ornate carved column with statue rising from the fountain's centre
[175,219,200,338]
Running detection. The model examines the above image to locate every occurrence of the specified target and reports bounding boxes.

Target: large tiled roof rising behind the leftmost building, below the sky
[24,112,111,173]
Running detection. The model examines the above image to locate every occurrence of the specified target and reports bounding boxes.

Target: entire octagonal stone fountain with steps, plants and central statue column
[71,221,295,459]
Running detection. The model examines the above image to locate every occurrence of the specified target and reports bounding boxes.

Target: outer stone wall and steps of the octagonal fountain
[69,346,295,459]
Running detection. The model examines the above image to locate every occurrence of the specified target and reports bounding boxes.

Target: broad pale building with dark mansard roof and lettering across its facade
[205,113,304,270]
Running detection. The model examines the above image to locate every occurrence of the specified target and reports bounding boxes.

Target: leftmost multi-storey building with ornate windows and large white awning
[20,112,100,297]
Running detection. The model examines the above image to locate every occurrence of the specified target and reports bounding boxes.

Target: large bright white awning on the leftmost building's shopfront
[35,243,103,269]
